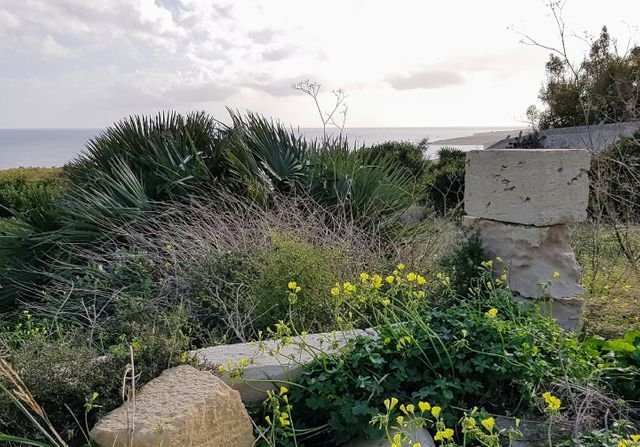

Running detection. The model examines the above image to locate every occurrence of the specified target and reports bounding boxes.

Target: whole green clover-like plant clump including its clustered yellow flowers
[250,265,632,446]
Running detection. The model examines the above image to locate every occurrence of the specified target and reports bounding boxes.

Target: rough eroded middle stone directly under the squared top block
[463,216,585,299]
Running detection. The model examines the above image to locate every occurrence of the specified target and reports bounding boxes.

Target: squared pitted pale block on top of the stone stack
[464,149,590,226]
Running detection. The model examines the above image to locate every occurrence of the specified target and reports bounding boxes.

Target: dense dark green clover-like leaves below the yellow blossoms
[258,295,595,445]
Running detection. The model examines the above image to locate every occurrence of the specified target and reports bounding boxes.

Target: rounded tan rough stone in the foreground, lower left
[91,366,254,447]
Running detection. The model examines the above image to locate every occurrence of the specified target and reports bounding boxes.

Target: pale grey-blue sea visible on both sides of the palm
[0,127,510,169]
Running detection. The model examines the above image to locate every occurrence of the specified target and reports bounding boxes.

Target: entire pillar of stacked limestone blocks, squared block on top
[464,149,590,331]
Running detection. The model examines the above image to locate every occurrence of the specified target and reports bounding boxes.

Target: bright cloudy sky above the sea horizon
[0,0,640,128]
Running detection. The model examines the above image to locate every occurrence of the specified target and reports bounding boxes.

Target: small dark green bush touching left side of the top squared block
[425,148,466,216]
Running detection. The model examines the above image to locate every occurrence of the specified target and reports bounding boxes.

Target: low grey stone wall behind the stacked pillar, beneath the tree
[487,121,640,152]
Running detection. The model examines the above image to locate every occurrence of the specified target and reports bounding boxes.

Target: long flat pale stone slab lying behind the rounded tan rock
[195,330,375,402]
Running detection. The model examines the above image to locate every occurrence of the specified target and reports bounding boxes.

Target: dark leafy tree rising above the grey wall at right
[540,27,640,129]
